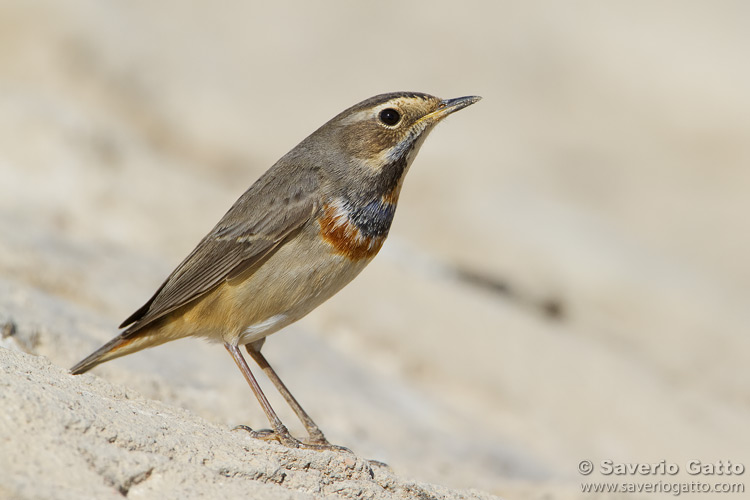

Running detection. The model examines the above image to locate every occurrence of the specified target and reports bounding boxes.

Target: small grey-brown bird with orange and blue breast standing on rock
[70,92,481,450]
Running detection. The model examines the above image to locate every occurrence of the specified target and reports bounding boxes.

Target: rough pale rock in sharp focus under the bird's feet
[0,348,500,499]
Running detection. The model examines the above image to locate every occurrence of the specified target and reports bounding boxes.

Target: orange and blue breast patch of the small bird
[318,198,396,261]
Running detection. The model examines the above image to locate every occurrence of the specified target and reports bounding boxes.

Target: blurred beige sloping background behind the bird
[0,0,750,498]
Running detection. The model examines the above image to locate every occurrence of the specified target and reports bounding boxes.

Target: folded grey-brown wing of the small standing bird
[120,165,317,336]
